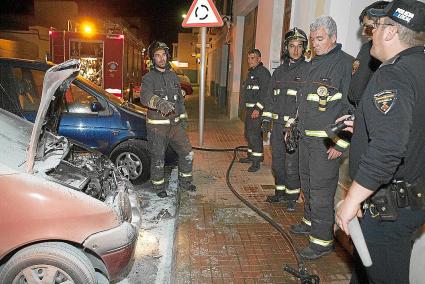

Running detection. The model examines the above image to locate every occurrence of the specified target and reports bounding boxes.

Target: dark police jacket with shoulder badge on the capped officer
[350,46,425,190]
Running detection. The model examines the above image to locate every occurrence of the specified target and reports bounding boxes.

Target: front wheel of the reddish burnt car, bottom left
[0,242,97,284]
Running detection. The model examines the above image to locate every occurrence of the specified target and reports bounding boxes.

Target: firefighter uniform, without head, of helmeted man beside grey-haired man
[262,57,307,205]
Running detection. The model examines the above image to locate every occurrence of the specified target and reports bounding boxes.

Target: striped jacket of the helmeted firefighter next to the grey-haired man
[262,58,308,126]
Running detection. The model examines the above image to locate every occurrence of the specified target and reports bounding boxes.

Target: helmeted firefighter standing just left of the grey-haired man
[262,28,308,211]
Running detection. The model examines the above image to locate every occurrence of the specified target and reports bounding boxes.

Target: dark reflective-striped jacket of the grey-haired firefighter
[298,44,353,152]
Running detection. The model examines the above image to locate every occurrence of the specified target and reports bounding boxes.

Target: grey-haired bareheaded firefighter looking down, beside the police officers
[291,16,353,259]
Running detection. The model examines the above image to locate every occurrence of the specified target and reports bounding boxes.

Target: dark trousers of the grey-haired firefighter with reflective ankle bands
[299,137,340,251]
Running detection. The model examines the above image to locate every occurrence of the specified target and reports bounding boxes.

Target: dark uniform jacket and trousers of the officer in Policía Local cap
[350,47,425,283]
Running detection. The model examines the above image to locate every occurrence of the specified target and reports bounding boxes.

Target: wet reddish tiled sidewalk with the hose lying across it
[171,93,351,284]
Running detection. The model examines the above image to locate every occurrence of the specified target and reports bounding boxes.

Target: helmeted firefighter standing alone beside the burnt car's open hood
[140,41,196,197]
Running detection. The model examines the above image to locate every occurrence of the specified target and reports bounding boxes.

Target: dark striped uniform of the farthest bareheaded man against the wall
[241,62,270,164]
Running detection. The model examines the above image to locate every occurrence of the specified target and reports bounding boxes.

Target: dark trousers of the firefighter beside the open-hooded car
[146,123,193,191]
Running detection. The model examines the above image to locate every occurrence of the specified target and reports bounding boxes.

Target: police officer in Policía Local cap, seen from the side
[336,0,425,283]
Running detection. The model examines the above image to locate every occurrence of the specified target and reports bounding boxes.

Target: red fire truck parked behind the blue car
[49,29,146,97]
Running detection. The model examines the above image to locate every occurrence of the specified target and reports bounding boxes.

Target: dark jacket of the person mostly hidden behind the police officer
[348,40,381,106]
